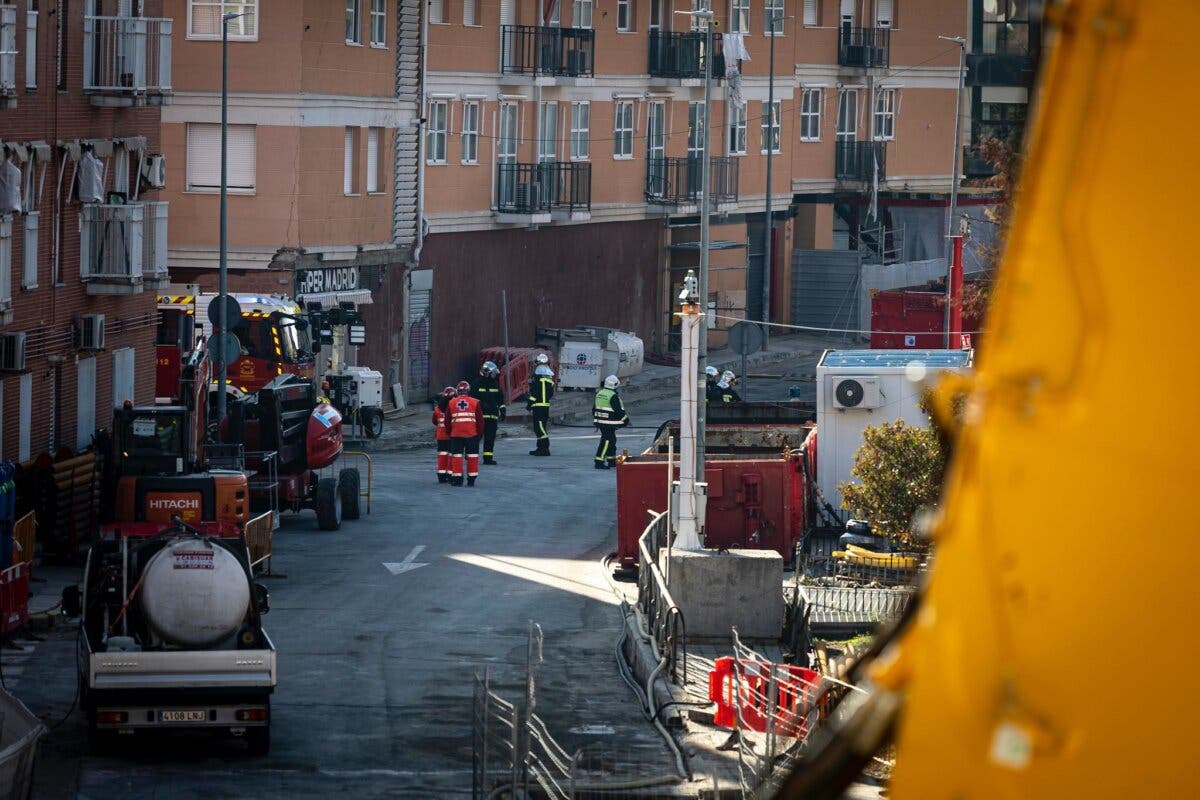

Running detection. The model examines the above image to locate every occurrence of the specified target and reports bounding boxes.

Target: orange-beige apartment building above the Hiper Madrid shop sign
[162,0,419,383]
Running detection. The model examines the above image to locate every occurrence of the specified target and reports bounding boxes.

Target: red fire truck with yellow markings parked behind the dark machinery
[155,285,316,402]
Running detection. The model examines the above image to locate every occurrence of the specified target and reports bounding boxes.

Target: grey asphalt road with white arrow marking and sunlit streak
[11,345,835,800]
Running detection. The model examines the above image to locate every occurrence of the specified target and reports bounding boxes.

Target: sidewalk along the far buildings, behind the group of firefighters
[347,333,844,452]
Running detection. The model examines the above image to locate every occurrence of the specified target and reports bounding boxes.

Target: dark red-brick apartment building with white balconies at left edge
[0,0,175,461]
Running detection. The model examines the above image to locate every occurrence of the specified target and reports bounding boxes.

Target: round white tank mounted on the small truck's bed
[140,537,250,648]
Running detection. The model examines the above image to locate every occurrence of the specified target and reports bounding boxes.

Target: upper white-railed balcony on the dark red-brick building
[83,17,172,106]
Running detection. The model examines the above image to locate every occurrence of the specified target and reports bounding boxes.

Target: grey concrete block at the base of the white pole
[660,549,784,639]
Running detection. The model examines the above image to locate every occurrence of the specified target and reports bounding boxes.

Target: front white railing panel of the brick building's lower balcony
[79,203,145,283]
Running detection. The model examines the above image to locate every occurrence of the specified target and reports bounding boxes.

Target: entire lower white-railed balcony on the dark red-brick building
[79,203,167,295]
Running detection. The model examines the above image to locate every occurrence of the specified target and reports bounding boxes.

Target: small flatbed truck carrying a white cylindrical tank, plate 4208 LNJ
[62,517,276,756]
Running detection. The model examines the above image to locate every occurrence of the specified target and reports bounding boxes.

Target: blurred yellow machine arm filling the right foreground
[779,0,1200,800]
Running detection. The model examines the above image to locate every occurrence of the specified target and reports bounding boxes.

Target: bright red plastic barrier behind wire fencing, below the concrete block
[708,656,821,738]
